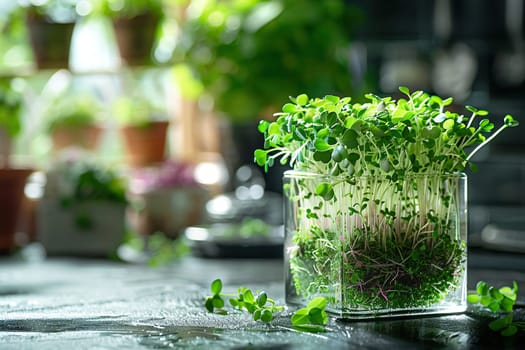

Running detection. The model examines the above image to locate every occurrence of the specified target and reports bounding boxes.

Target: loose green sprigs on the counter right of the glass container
[467,281,525,337]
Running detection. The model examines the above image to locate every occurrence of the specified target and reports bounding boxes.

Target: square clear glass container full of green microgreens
[255,87,517,318]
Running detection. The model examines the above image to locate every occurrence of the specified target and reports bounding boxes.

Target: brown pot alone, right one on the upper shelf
[113,13,160,66]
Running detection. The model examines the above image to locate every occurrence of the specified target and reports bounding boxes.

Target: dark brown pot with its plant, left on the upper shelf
[23,0,78,69]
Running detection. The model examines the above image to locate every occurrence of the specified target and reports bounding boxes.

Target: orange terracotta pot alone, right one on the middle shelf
[120,121,169,167]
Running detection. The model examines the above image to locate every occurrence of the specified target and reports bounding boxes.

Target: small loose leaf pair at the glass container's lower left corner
[291,297,328,332]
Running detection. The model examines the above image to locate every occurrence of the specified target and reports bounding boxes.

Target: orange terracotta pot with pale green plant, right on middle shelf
[113,94,169,167]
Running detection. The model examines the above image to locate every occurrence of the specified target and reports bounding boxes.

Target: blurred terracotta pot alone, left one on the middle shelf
[51,125,102,151]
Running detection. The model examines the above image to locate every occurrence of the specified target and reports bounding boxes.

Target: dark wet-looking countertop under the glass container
[0,247,525,350]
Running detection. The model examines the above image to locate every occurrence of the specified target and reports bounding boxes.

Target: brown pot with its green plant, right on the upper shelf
[93,0,164,66]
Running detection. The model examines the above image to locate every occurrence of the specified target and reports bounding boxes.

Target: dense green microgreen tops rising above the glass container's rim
[255,87,518,176]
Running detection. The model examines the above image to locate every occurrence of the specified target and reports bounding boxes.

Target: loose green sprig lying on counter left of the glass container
[205,279,284,323]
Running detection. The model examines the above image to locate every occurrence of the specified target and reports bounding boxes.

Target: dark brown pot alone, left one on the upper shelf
[26,13,75,69]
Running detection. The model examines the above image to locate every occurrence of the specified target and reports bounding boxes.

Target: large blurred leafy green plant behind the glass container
[174,0,360,122]
